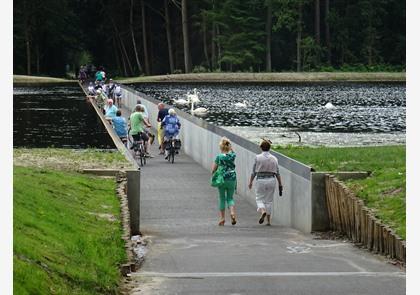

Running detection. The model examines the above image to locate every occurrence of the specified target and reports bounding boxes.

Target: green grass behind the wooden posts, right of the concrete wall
[275,146,406,239]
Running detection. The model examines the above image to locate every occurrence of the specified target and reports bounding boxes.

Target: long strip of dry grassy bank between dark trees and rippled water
[118,72,405,83]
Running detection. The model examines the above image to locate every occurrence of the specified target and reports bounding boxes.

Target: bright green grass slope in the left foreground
[13,166,126,294]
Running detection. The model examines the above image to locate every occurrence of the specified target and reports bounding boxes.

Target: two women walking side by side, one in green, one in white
[212,137,283,226]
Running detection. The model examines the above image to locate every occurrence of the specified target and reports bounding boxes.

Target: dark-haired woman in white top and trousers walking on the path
[248,140,283,225]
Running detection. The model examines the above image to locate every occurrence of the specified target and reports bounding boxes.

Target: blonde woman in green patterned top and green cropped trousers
[212,137,236,226]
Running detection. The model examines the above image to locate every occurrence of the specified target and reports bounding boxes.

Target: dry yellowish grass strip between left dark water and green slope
[13,148,133,171]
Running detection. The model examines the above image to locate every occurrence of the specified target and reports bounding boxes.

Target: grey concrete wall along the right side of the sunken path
[123,86,313,233]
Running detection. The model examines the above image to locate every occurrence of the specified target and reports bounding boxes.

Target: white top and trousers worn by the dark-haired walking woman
[252,152,279,215]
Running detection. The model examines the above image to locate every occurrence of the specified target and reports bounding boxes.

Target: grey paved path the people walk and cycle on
[117,107,405,295]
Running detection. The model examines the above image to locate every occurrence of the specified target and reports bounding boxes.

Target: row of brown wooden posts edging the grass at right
[325,174,406,263]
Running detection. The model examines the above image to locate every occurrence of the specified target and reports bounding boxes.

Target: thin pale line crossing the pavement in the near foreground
[131,272,405,279]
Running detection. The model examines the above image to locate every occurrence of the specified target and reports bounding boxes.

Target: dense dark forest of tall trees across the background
[13,0,405,76]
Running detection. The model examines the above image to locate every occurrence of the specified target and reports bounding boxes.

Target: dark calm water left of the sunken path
[13,86,115,149]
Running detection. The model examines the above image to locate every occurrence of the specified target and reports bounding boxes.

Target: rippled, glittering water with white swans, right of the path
[133,83,406,133]
